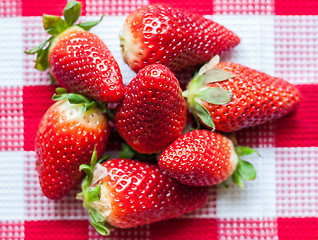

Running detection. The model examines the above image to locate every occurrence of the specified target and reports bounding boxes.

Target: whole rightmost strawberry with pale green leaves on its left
[183,57,300,132]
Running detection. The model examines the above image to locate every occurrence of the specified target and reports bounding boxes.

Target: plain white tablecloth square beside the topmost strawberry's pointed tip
[207,15,275,75]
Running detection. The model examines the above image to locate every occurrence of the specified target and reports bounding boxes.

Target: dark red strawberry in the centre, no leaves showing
[114,64,186,154]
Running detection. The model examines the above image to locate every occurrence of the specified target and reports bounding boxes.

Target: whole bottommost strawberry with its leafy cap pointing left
[78,151,208,235]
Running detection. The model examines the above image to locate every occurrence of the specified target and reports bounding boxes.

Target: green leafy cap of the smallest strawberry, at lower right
[232,146,260,188]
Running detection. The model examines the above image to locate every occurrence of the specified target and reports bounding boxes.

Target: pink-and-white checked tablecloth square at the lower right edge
[276,147,318,217]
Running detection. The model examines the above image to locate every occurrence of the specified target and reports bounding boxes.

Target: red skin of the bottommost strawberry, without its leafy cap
[100,159,208,228]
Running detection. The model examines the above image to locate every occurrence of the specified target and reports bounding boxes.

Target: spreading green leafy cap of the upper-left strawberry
[24,1,103,71]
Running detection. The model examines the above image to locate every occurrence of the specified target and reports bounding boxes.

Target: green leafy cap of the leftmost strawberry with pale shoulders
[52,88,106,113]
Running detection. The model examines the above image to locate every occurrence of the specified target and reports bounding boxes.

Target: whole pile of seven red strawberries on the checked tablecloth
[26,1,300,235]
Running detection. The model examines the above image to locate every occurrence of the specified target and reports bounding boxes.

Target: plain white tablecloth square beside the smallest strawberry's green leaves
[216,148,276,218]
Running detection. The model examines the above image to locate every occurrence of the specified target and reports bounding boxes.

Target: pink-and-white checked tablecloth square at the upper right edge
[275,16,318,84]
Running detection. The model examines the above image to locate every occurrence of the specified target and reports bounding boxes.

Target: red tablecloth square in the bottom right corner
[277,218,318,240]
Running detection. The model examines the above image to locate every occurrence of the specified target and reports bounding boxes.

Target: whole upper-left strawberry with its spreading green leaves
[26,1,124,103]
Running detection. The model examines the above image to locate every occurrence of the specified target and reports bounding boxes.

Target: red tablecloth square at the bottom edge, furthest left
[24,220,89,240]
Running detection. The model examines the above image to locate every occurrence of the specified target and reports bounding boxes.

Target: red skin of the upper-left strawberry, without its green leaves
[49,26,124,102]
